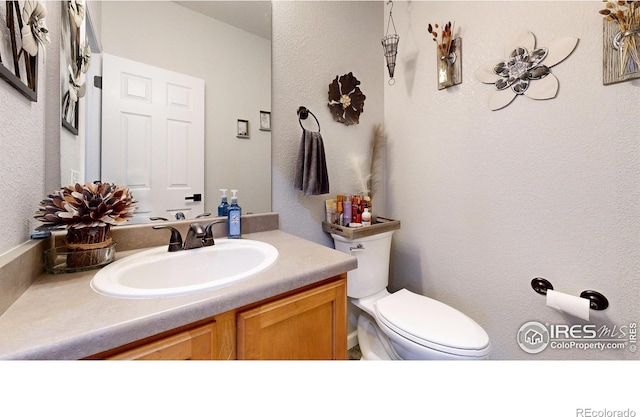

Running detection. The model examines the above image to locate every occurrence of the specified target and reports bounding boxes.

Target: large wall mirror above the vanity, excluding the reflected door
[60,0,271,222]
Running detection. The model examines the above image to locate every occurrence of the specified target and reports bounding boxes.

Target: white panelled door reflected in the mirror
[101,54,204,221]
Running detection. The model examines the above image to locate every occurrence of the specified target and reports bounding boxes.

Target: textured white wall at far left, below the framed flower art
[0,1,60,254]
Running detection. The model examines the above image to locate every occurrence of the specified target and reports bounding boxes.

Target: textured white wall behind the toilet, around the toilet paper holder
[382,1,640,359]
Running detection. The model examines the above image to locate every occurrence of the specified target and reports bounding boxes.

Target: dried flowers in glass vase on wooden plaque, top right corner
[600,0,640,75]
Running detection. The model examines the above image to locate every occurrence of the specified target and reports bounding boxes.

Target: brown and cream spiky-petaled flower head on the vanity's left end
[34,182,137,230]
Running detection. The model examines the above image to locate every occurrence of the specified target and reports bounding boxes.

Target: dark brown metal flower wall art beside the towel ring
[328,72,367,126]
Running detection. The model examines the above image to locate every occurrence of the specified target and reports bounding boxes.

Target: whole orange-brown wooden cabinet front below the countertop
[87,274,347,360]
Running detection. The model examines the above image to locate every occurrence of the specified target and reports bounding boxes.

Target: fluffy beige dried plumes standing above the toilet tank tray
[350,124,387,198]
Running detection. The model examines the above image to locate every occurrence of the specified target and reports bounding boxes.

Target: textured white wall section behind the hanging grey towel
[272,1,385,246]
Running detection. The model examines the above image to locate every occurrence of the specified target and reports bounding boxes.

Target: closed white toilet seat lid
[376,289,489,350]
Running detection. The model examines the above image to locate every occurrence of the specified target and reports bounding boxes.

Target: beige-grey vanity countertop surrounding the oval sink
[0,230,357,359]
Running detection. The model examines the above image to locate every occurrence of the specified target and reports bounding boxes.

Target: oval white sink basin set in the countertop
[91,239,278,298]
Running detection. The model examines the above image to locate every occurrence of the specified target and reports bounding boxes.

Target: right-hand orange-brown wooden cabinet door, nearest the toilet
[237,277,347,359]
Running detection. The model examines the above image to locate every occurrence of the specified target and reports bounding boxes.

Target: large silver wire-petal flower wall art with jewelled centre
[475,32,578,110]
